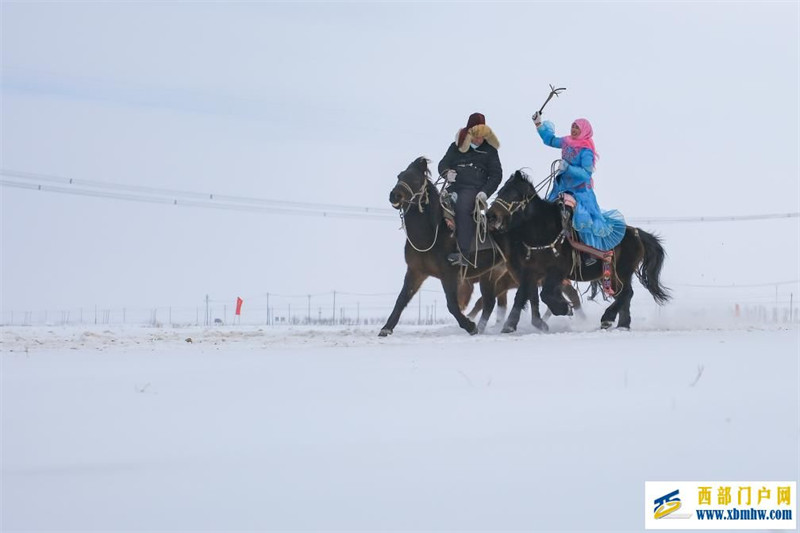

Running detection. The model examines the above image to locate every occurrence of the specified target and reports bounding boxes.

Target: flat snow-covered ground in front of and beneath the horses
[0,317,800,531]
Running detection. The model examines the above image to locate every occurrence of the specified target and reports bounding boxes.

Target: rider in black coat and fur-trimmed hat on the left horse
[439,113,503,266]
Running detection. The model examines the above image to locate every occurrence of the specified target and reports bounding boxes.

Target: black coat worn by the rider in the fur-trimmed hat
[439,141,503,196]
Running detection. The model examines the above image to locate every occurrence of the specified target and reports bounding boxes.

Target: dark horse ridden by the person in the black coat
[379,157,507,337]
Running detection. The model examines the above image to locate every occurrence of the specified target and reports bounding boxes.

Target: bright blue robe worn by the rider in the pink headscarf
[536,121,626,250]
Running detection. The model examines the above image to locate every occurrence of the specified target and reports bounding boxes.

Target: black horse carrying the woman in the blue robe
[487,171,670,333]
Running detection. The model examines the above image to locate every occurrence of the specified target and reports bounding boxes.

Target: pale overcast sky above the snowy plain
[0,1,800,311]
